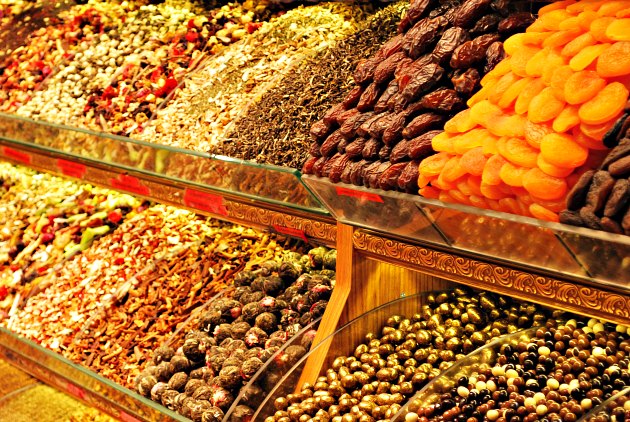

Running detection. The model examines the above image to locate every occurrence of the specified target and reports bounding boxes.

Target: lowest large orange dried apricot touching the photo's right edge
[579,82,628,125]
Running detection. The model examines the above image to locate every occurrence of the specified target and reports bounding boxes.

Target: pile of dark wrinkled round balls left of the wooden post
[137,247,336,422]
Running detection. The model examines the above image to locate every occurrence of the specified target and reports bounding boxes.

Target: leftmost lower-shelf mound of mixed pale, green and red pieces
[0,163,141,320]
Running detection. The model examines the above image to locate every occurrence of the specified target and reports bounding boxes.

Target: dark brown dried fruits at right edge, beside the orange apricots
[560,104,630,235]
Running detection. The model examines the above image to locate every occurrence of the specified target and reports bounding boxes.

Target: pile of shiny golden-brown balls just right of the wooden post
[266,288,560,422]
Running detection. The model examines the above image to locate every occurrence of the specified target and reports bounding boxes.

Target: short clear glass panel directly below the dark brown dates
[302,175,445,245]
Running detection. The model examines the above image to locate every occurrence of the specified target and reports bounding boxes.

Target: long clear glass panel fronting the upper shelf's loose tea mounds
[0,113,326,214]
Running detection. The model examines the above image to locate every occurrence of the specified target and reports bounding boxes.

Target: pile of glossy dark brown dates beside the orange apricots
[303,0,534,193]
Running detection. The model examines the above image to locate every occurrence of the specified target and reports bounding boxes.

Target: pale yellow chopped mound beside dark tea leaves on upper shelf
[138,3,369,152]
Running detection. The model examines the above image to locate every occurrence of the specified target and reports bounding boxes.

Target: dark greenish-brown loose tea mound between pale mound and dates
[222,1,409,168]
